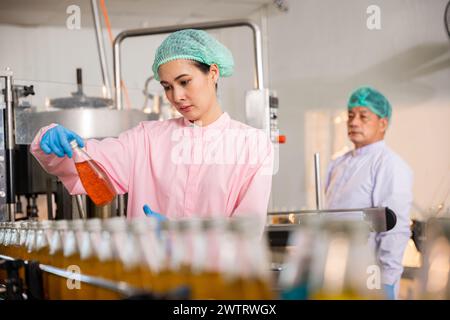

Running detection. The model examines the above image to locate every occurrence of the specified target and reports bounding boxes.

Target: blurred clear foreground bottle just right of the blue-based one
[309,221,382,300]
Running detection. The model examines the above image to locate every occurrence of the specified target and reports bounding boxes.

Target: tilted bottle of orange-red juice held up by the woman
[70,140,116,206]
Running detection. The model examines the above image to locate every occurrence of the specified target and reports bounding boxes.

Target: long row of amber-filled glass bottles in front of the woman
[0,218,272,299]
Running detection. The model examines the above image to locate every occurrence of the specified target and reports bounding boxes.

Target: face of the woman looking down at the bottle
[158,59,219,121]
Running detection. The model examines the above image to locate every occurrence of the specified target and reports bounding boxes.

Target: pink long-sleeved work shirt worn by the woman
[31,113,274,230]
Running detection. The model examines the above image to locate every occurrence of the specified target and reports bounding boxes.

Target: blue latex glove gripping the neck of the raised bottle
[40,125,84,158]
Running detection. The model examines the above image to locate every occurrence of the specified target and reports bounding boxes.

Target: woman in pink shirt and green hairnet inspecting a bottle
[31,29,273,231]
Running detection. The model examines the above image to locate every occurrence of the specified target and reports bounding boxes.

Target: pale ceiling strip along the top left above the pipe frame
[0,0,274,29]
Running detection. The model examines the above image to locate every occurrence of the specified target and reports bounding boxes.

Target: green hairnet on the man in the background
[348,87,392,121]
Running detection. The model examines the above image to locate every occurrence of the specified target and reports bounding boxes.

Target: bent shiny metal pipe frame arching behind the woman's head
[113,19,264,110]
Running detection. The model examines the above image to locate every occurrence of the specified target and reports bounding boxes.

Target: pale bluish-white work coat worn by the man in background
[325,141,413,285]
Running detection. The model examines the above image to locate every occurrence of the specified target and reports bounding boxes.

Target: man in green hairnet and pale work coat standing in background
[325,87,413,299]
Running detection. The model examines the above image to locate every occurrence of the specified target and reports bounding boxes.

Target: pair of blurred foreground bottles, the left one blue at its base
[279,216,384,300]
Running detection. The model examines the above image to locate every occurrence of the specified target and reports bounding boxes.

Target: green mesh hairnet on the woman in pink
[152,29,234,81]
